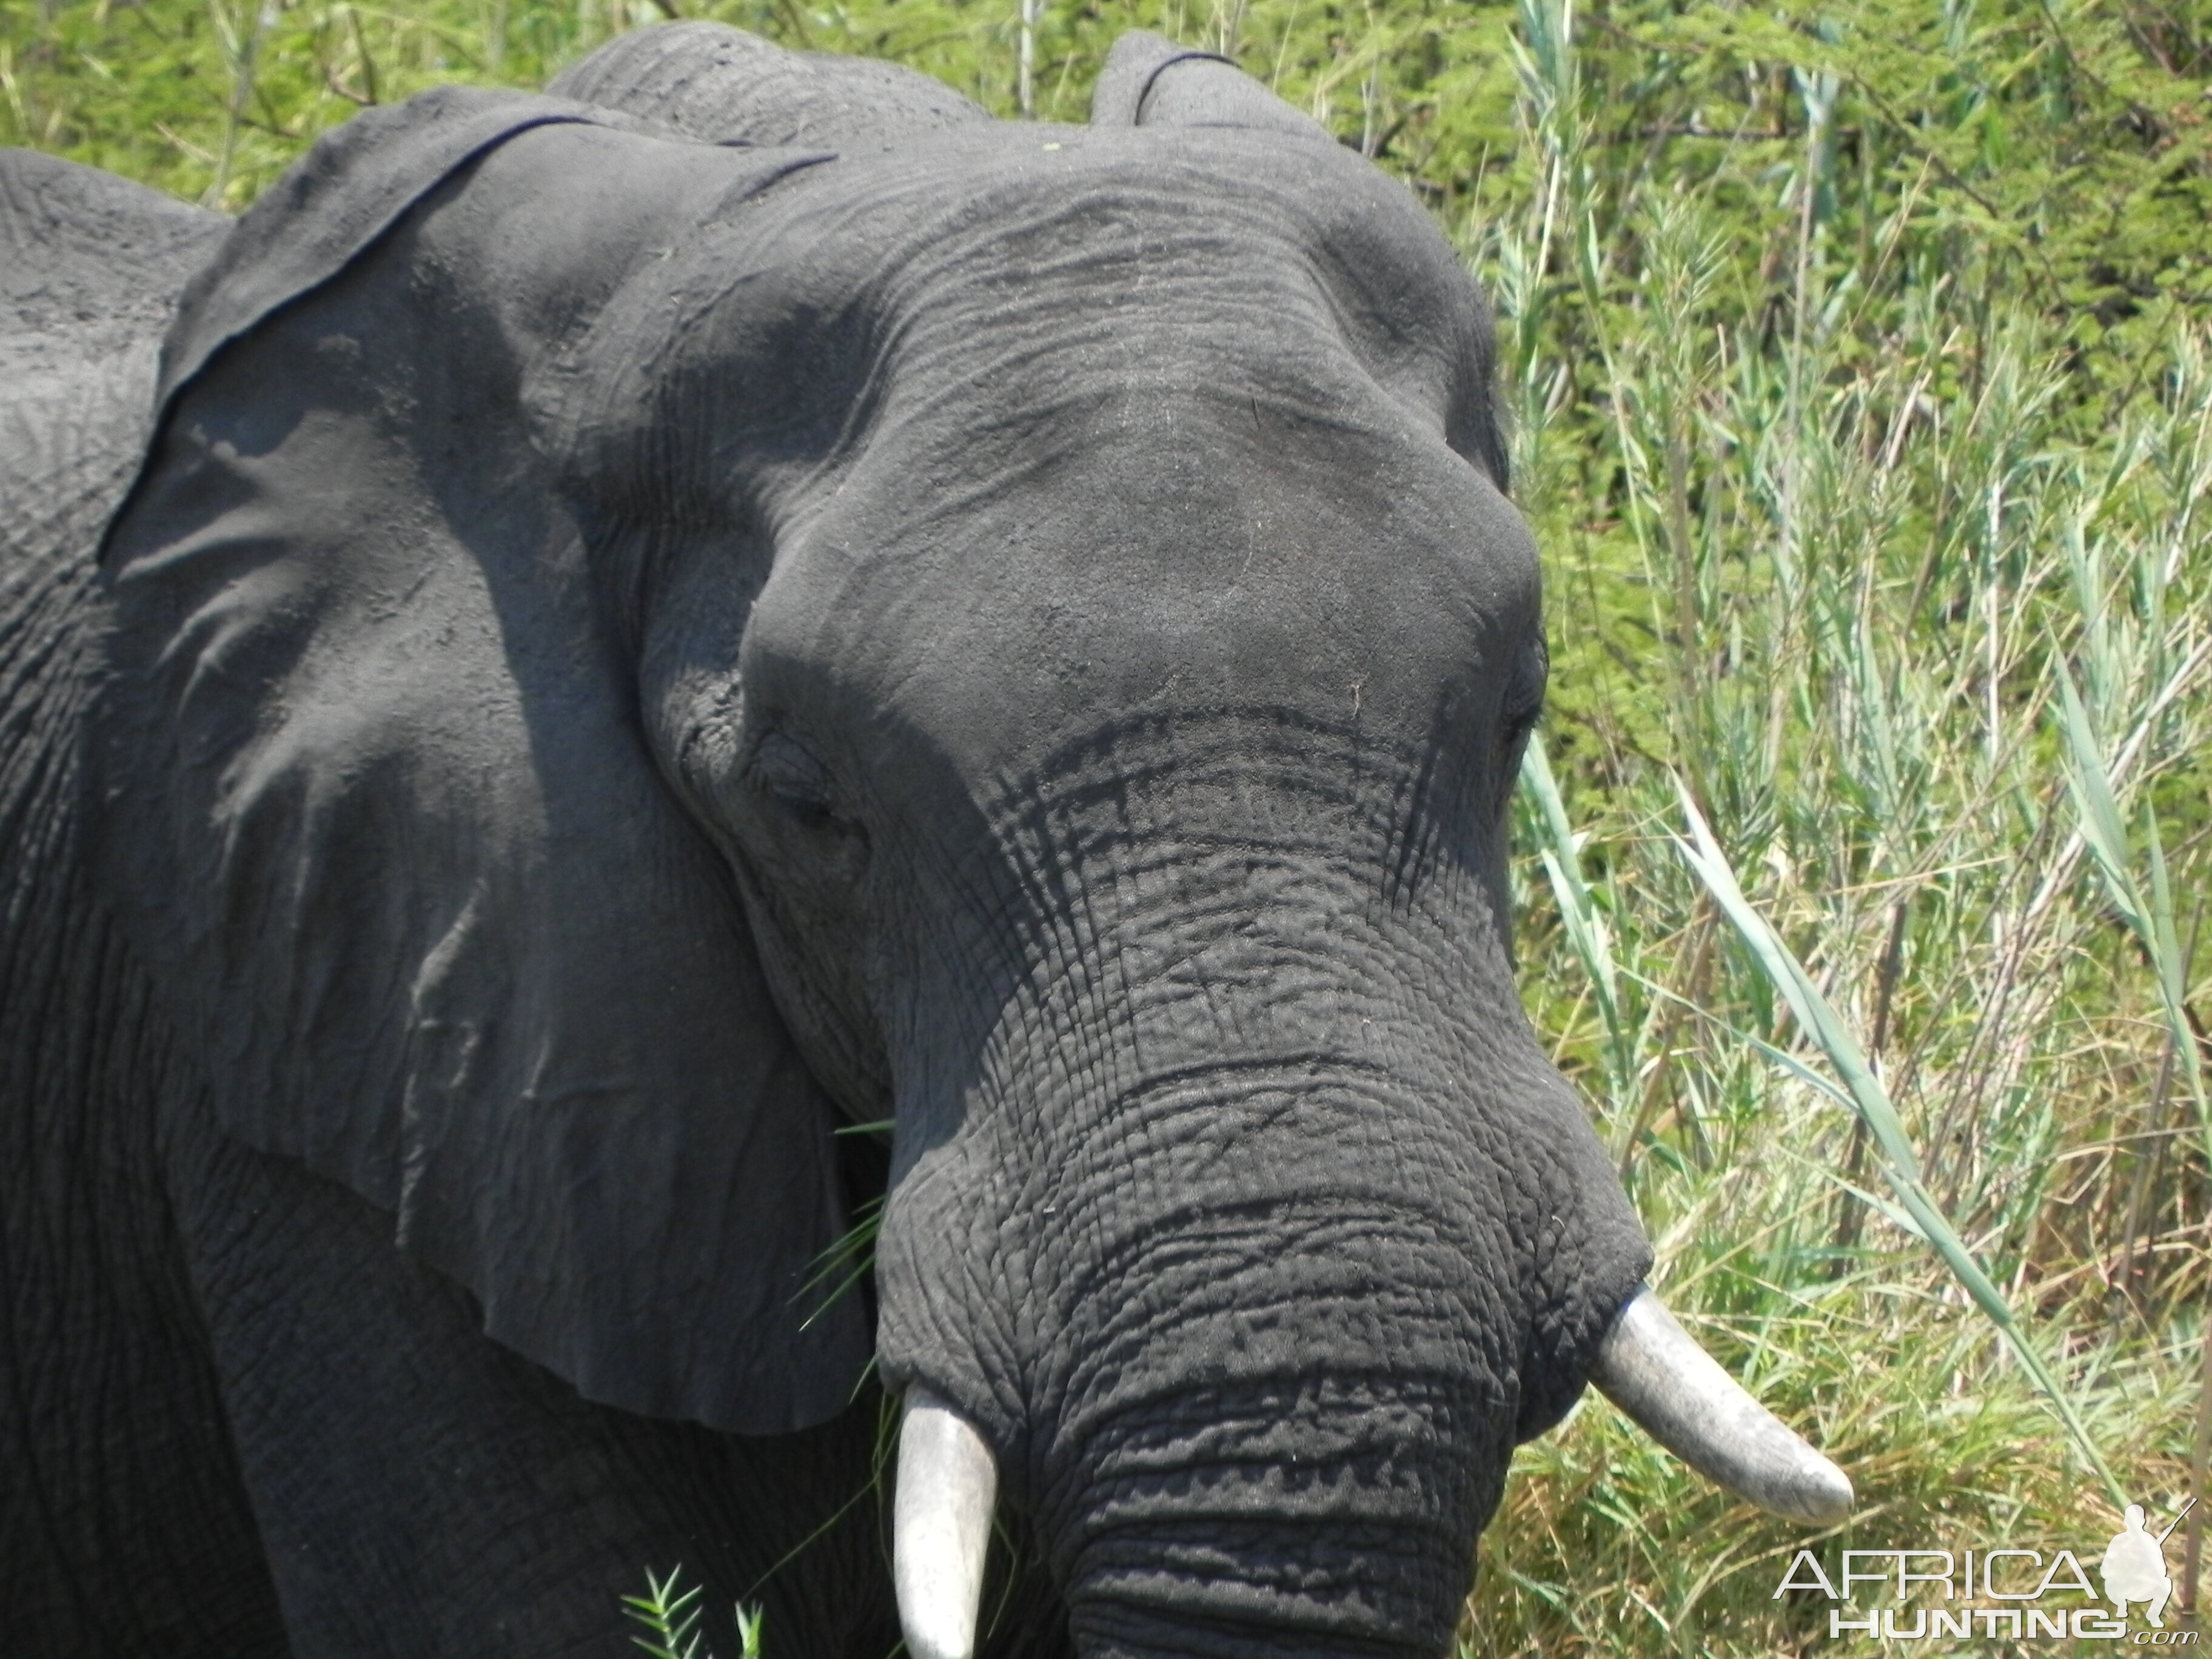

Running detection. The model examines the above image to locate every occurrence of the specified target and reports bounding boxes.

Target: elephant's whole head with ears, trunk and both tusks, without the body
[95,24,1849,1655]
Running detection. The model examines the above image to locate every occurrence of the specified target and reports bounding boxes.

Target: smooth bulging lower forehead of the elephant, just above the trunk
[748,414,1537,787]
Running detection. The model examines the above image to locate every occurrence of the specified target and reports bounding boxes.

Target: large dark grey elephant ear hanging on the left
[93,93,870,1433]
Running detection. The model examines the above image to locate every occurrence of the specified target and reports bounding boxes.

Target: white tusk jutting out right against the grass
[1590,1287,1854,1526]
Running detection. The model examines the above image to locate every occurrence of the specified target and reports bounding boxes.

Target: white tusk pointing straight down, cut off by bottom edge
[891,1387,997,1659]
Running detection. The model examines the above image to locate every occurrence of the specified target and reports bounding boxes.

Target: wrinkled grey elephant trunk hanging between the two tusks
[876,712,1650,1659]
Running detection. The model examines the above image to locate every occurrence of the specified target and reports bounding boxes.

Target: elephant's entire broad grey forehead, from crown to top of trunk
[615,126,1537,805]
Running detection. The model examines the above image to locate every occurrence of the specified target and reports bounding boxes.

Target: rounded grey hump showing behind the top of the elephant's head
[546,22,991,150]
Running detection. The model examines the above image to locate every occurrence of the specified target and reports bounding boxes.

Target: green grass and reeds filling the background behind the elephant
[0,0,2212,1655]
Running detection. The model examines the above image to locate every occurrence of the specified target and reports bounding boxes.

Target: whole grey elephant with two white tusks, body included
[0,22,1851,1659]
